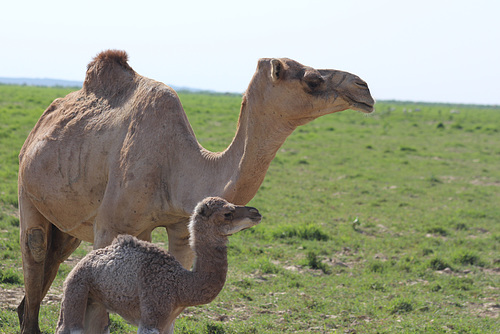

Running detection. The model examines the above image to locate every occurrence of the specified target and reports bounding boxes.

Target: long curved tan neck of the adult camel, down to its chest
[166,78,296,216]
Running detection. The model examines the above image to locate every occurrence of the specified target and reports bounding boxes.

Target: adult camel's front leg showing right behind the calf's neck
[167,218,194,269]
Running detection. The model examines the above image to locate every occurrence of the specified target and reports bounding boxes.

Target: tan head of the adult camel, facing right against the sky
[247,58,375,126]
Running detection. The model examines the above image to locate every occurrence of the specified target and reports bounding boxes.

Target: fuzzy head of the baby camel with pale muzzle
[189,197,262,247]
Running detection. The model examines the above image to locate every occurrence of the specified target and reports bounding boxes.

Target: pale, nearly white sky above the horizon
[0,0,500,105]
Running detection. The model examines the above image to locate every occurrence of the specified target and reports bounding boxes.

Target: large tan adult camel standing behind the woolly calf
[18,51,374,333]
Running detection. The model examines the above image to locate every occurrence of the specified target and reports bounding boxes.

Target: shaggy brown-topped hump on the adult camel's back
[83,50,136,95]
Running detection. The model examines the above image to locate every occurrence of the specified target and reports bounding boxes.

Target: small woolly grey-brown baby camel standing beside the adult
[56,197,262,334]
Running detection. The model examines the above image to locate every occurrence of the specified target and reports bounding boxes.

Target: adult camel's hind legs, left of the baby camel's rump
[17,196,80,334]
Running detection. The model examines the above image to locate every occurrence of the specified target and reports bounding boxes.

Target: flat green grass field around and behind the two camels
[0,86,500,334]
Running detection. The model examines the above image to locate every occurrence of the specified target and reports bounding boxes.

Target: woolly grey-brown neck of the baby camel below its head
[181,244,227,306]
